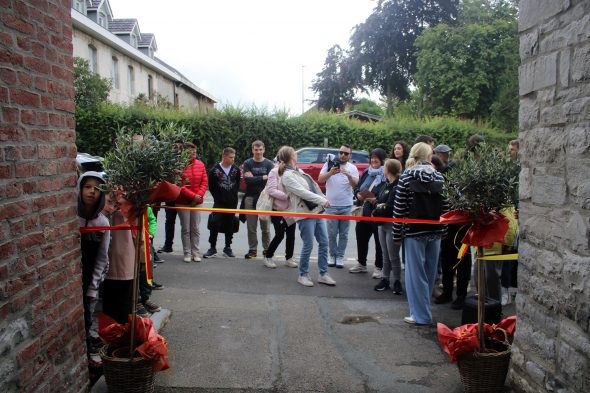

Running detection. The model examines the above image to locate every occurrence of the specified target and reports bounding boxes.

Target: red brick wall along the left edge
[0,0,88,392]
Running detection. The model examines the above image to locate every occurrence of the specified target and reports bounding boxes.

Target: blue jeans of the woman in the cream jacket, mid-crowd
[297,218,328,276]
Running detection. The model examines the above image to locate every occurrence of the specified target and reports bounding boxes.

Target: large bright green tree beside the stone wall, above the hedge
[416,0,519,131]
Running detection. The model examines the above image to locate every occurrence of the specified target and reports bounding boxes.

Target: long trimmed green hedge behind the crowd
[76,105,516,166]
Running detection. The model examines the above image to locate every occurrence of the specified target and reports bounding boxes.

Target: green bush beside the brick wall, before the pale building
[74,57,112,110]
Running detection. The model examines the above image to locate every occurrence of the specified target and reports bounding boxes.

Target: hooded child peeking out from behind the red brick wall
[77,171,111,353]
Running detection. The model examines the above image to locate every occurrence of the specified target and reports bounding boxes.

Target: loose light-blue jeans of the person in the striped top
[404,237,440,324]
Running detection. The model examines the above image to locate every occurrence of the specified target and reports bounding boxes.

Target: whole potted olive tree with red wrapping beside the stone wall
[438,144,520,392]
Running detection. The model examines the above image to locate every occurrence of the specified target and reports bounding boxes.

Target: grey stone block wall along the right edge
[510,0,590,393]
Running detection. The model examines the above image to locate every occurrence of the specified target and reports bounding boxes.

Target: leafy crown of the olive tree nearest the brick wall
[104,123,189,207]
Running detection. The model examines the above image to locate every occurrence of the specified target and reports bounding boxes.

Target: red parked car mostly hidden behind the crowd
[240,147,369,192]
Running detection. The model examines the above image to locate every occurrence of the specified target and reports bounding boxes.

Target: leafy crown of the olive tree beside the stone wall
[445,144,520,216]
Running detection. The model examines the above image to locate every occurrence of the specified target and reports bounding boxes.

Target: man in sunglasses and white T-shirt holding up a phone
[318,145,359,269]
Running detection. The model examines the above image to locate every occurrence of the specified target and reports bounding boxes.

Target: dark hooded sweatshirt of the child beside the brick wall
[77,171,111,298]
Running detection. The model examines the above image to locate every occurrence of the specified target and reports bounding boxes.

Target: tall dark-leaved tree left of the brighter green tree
[350,0,458,111]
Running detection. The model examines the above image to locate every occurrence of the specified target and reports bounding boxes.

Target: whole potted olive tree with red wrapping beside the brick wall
[99,124,189,392]
